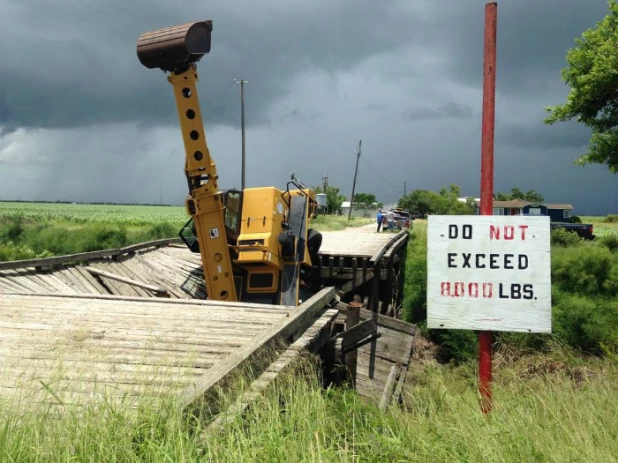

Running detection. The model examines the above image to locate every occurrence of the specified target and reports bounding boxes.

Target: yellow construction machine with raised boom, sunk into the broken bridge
[137,21,322,306]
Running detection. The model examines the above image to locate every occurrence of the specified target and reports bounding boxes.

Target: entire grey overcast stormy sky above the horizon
[0,0,618,214]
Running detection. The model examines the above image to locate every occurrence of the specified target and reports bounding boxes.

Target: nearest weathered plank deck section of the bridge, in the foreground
[0,288,336,412]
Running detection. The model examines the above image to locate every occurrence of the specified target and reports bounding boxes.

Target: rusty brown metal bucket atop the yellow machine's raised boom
[137,21,212,72]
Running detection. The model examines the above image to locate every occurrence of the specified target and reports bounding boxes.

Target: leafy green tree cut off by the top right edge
[544,0,618,173]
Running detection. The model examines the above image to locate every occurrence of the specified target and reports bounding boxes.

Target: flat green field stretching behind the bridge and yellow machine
[0,202,373,261]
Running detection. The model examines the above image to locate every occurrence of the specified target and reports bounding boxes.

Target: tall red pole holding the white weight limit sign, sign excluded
[479,2,498,413]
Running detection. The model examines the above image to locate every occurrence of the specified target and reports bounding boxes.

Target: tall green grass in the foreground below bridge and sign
[0,358,618,463]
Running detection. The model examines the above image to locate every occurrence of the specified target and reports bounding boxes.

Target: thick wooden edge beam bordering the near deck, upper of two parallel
[179,287,335,409]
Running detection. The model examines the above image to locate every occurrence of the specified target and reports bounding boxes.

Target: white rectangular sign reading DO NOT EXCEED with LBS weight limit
[427,215,551,333]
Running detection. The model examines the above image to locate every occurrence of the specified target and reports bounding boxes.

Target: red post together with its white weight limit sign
[427,2,551,413]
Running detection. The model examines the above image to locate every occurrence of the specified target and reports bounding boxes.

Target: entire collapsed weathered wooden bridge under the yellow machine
[0,231,416,420]
